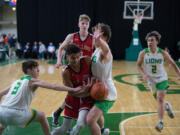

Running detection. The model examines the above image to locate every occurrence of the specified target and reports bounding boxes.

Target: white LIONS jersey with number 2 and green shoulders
[144,48,167,83]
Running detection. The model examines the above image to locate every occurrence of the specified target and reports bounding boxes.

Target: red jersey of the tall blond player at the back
[73,32,93,57]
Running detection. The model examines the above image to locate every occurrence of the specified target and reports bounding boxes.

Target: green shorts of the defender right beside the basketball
[94,100,115,113]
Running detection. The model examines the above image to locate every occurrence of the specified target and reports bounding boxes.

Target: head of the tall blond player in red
[78,14,91,31]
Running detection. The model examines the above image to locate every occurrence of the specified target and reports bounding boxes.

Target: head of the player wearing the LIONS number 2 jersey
[145,31,161,47]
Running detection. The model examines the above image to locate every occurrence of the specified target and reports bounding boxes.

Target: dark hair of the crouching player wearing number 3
[22,60,39,74]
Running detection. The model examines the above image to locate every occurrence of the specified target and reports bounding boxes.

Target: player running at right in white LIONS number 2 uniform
[137,31,180,132]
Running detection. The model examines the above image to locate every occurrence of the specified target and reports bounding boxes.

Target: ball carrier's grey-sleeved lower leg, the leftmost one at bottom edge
[51,117,72,135]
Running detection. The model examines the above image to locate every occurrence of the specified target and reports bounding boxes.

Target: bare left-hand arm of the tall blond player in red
[55,34,73,68]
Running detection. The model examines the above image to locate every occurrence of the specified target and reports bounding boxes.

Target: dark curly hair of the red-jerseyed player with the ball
[65,44,81,55]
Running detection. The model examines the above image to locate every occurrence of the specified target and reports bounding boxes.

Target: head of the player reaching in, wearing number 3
[22,60,39,78]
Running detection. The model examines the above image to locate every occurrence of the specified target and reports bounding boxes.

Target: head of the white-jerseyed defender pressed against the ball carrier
[92,23,112,42]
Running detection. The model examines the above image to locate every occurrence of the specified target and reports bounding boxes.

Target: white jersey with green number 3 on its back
[1,75,34,109]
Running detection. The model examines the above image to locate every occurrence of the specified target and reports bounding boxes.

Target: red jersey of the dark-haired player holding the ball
[65,58,91,88]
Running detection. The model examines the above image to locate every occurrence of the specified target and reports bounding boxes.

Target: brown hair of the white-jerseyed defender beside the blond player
[99,23,112,42]
